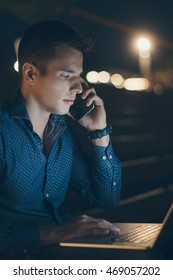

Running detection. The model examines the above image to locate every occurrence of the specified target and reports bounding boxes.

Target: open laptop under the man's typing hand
[60,203,173,250]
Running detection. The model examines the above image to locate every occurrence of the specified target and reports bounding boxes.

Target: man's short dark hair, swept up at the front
[18,20,90,82]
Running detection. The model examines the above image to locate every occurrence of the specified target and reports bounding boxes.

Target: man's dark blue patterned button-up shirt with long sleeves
[0,90,121,256]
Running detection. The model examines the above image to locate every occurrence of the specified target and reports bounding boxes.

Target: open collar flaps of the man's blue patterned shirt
[8,89,66,125]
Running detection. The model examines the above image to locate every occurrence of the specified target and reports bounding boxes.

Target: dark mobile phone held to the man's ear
[70,80,94,121]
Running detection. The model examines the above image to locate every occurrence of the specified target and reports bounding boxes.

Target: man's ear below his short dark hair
[22,63,38,85]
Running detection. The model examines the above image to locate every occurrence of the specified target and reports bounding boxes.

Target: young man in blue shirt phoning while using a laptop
[0,21,121,258]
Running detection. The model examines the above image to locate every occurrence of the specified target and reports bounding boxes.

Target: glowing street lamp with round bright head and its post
[137,38,151,80]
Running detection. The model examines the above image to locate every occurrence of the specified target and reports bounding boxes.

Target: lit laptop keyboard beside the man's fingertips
[114,224,161,243]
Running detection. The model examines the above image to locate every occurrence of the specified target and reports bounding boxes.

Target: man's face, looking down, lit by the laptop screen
[32,46,83,115]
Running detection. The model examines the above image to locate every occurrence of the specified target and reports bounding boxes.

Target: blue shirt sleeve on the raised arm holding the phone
[69,143,121,209]
